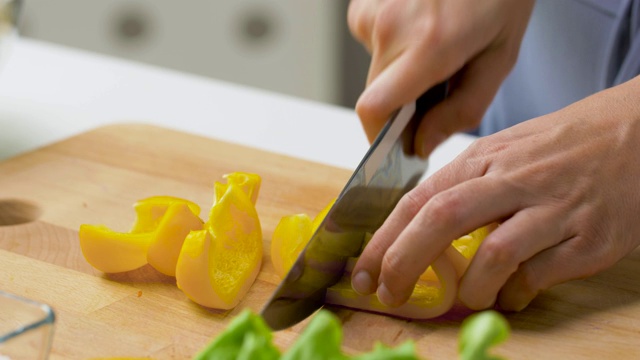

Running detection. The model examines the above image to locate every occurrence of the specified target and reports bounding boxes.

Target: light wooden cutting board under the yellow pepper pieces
[0,125,640,359]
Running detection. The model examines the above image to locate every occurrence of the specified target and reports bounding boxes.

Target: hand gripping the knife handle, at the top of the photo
[348,0,533,157]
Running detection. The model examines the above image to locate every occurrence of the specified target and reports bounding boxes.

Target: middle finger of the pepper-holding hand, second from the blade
[378,176,521,306]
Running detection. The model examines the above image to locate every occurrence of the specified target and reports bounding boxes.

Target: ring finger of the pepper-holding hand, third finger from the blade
[458,206,566,310]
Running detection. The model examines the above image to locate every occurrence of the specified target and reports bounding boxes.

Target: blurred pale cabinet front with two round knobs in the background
[20,0,369,107]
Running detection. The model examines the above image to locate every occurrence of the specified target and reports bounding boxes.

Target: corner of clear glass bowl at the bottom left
[0,290,55,360]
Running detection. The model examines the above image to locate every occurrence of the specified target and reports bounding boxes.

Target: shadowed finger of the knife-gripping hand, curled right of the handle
[415,45,515,158]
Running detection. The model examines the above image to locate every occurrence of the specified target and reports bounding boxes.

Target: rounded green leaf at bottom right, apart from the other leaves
[458,310,509,360]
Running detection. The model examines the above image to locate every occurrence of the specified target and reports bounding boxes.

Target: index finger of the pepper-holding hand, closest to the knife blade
[351,151,486,295]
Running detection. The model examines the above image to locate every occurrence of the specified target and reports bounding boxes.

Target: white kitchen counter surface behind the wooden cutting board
[0,38,473,171]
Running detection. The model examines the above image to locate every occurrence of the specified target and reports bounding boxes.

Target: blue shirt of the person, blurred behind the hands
[477,0,640,135]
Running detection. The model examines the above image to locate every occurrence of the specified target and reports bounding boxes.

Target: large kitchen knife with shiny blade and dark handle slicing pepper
[261,82,448,330]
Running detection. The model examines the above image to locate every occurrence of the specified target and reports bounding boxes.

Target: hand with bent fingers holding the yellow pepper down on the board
[352,77,640,311]
